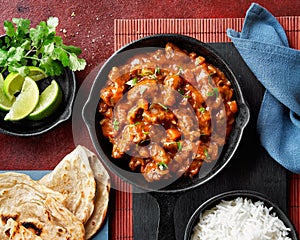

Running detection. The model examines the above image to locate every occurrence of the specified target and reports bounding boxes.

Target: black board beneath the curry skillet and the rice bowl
[133,43,289,240]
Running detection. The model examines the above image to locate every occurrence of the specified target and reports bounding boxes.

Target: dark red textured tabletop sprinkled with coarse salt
[0,0,300,239]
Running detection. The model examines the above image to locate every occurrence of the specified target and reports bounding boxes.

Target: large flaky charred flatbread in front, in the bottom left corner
[0,172,85,240]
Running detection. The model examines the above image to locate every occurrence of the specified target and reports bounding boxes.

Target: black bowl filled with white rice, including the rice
[184,190,299,240]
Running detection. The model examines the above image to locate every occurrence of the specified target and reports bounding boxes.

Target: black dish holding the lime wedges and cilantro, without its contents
[0,69,76,137]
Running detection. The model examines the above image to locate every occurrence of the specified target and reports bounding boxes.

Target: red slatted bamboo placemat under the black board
[111,16,300,240]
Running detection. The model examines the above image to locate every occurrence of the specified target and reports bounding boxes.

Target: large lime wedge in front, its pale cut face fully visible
[4,77,39,121]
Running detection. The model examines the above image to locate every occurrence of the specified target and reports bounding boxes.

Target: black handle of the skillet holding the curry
[150,192,180,240]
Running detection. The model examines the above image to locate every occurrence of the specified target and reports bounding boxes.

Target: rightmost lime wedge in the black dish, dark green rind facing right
[27,80,62,121]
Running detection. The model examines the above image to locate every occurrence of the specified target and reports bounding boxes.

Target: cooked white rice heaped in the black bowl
[191,197,291,240]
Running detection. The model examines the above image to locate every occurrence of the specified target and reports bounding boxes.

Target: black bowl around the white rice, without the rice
[184,190,298,240]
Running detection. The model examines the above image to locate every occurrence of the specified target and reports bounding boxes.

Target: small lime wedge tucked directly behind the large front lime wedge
[3,72,24,101]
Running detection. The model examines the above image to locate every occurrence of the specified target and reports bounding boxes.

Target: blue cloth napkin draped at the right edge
[227,3,300,173]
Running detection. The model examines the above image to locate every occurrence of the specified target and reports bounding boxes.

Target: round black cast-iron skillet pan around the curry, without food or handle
[83,34,250,192]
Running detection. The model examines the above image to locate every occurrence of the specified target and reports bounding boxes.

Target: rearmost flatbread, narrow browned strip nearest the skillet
[82,147,110,239]
